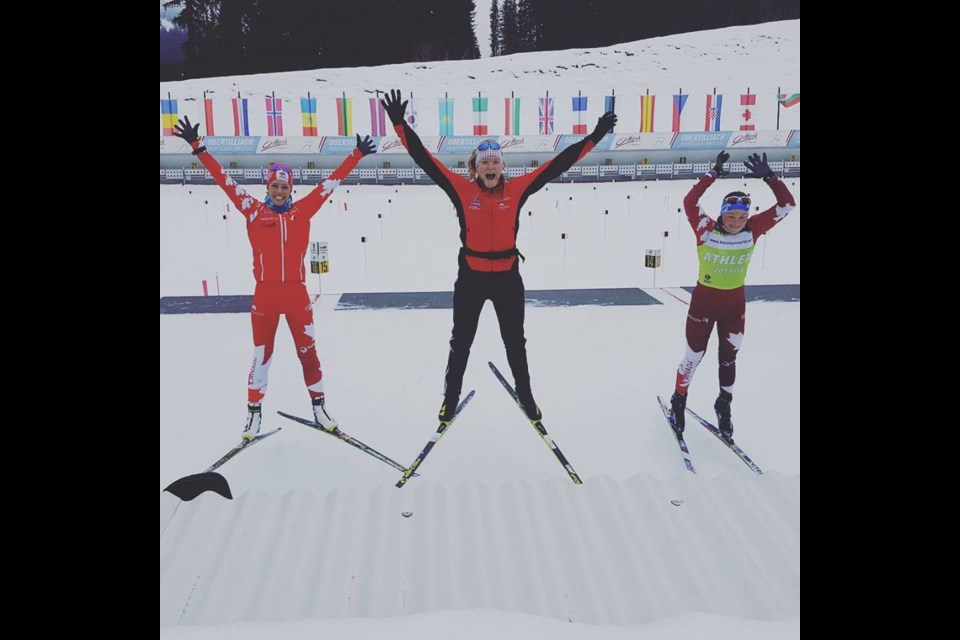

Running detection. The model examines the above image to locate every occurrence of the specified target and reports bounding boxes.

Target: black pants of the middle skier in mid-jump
[444,264,532,397]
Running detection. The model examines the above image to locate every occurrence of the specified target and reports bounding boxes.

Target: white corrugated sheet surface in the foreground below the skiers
[160,468,800,627]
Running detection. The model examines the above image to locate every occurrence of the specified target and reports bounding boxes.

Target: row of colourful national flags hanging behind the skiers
[160,90,800,136]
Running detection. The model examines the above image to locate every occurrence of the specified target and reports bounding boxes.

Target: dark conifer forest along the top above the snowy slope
[160,0,800,82]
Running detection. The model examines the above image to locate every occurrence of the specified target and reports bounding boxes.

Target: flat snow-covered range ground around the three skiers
[160,181,800,493]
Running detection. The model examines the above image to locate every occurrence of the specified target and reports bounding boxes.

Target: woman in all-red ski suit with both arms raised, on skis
[174,117,375,440]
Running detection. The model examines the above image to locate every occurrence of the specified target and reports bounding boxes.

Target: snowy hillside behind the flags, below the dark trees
[160,20,800,135]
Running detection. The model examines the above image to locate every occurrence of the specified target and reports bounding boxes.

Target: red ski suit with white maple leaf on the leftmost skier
[193,142,363,403]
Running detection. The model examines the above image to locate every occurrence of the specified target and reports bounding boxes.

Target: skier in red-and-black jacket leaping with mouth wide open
[383,90,617,422]
